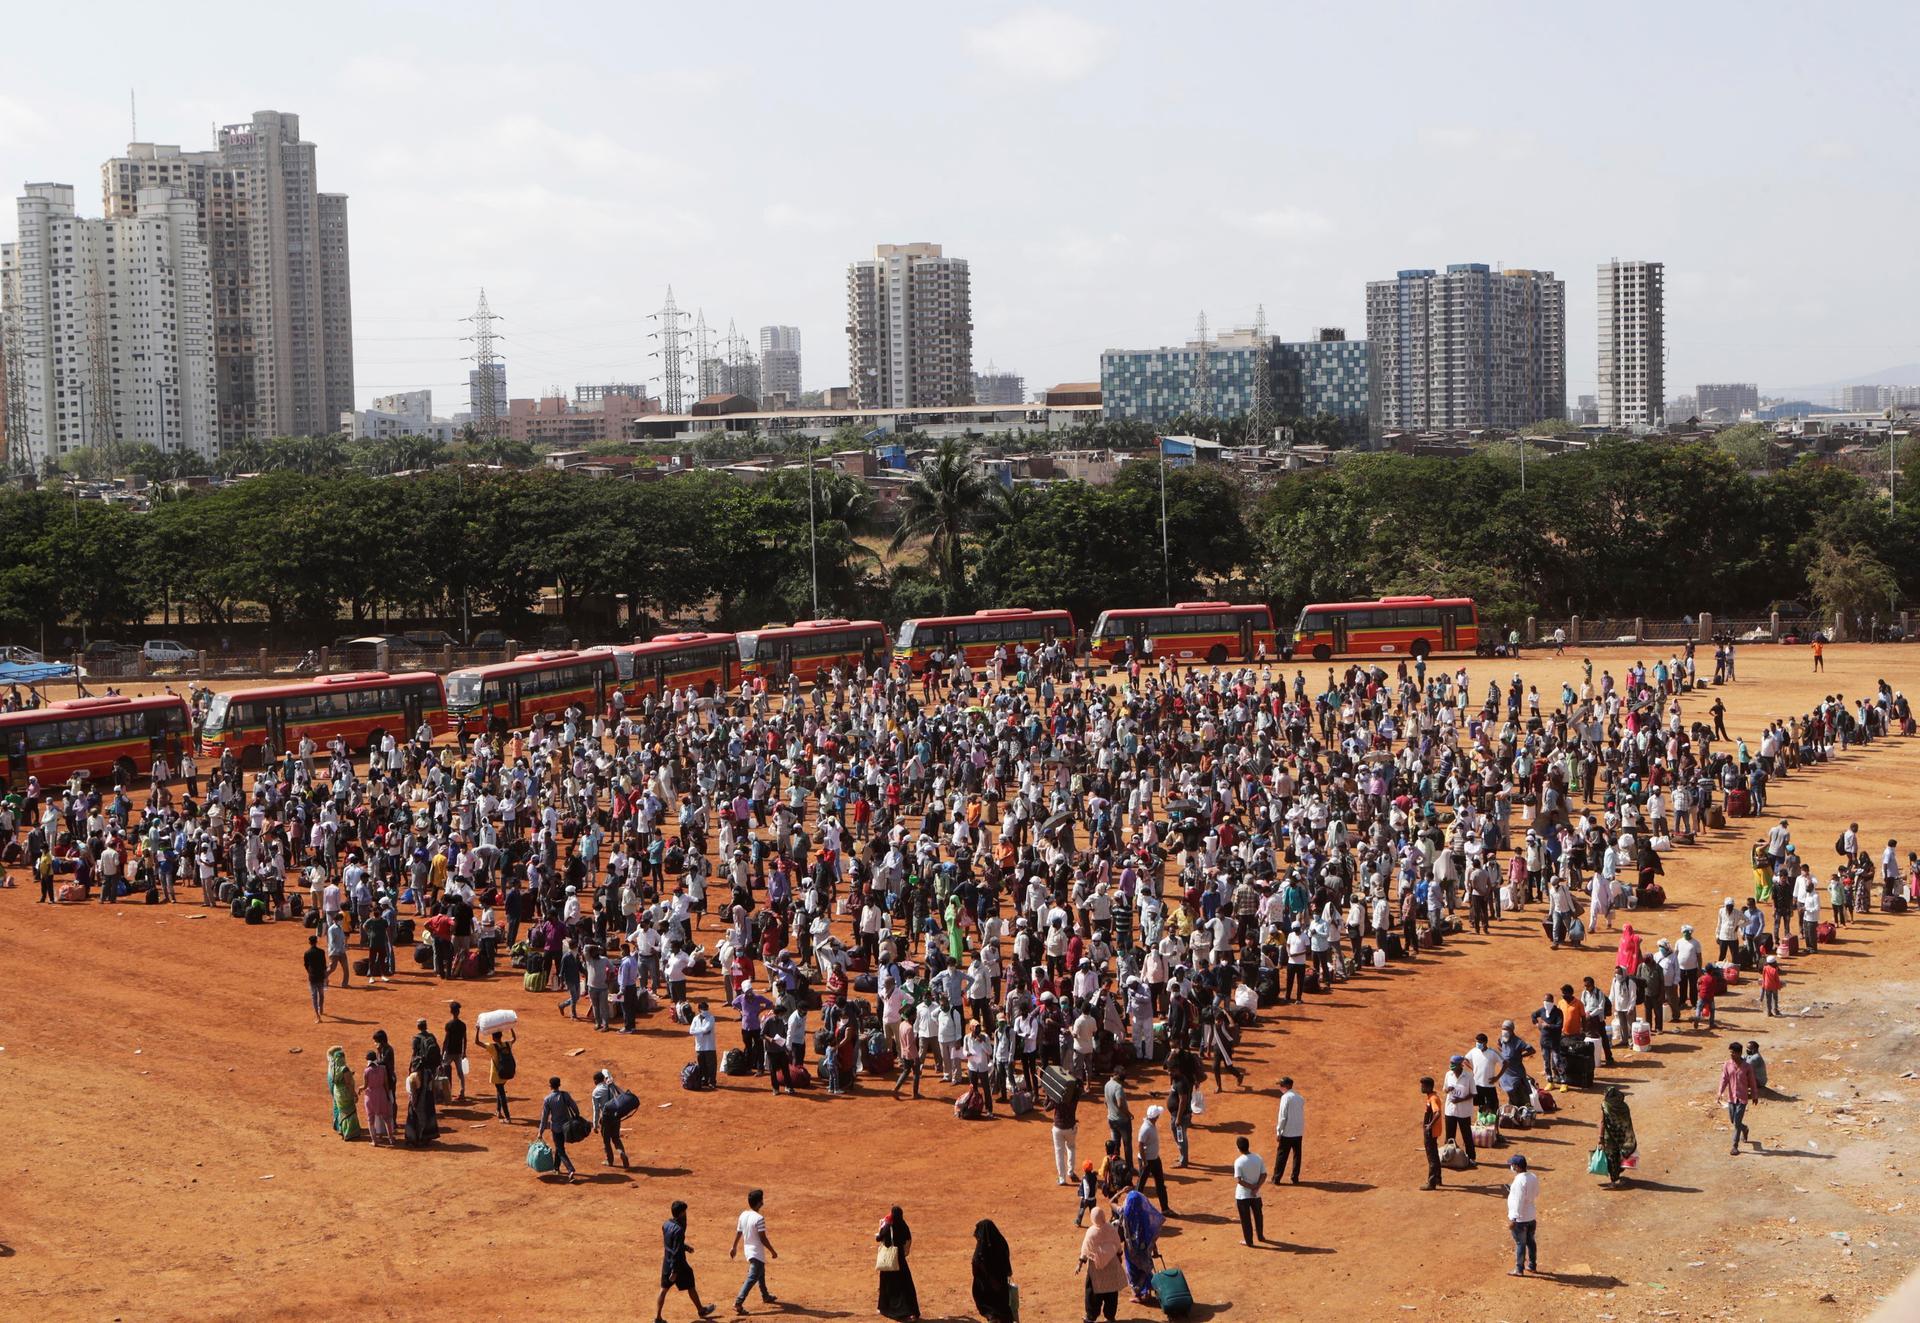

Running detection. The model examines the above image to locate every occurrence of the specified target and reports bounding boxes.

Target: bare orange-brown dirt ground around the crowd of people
[0,647,1920,1323]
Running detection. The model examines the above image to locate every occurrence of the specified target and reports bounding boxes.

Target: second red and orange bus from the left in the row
[200,670,447,762]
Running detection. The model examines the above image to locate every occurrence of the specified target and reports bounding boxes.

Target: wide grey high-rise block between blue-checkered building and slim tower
[1367,261,1567,434]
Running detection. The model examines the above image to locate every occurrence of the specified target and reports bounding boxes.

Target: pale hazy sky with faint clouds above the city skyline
[0,0,1920,413]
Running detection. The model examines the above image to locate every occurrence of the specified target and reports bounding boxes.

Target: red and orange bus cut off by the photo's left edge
[0,693,188,789]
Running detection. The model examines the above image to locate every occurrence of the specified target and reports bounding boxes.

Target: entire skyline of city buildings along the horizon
[0,140,1920,463]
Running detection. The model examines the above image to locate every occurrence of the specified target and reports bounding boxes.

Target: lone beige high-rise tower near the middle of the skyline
[847,244,973,409]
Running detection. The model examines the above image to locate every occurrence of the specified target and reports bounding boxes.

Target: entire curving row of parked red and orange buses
[0,597,1480,785]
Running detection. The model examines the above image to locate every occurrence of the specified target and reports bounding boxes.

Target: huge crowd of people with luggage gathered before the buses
[0,645,1920,1317]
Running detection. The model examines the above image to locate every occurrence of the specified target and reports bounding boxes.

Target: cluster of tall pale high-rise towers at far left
[0,109,355,467]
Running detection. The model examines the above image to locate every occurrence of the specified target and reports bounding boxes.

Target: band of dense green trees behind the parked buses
[0,433,1920,645]
